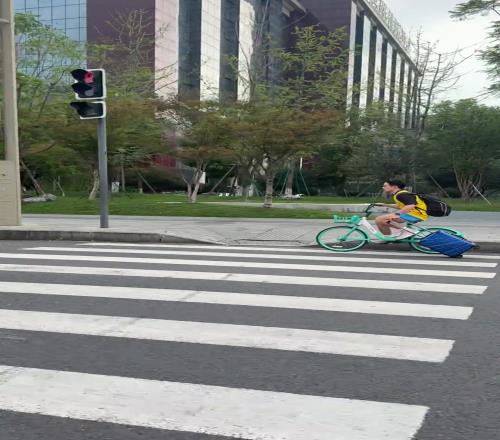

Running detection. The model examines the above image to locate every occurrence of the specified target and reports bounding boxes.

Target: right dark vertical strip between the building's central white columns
[219,0,240,101]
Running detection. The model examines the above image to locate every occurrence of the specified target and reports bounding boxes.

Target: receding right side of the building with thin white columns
[301,0,418,127]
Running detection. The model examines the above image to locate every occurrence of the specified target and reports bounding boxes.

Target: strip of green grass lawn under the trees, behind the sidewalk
[23,194,500,219]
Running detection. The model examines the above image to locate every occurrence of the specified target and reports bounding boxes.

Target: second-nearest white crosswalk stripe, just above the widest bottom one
[0,309,454,362]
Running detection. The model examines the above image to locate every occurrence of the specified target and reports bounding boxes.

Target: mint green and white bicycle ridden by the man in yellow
[316,203,464,254]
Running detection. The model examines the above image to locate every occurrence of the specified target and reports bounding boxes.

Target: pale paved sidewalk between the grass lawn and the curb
[0,212,500,245]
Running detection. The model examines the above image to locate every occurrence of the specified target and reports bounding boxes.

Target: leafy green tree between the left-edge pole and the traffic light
[15,14,85,193]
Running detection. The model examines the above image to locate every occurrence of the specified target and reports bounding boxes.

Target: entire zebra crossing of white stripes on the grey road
[0,243,500,440]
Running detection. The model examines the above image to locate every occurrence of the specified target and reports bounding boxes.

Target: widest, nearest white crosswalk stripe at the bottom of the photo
[0,366,429,440]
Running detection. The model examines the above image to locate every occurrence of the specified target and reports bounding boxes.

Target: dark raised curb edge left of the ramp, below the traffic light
[0,230,218,244]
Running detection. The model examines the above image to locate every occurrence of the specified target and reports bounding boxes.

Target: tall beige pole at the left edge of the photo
[0,0,21,226]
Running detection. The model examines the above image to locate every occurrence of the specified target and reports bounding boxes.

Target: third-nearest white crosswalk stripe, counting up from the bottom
[0,282,473,320]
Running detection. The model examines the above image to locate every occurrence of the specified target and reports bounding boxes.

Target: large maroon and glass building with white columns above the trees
[15,0,418,122]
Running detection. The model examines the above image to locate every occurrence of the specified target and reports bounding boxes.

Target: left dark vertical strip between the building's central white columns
[179,0,202,99]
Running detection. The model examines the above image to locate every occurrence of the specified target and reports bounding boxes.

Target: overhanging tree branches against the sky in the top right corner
[450,0,500,93]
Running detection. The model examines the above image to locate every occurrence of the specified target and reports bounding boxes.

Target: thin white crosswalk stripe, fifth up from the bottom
[0,253,496,279]
